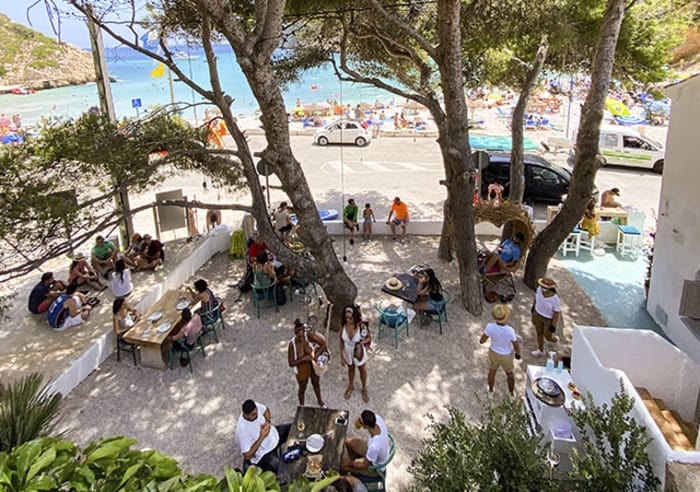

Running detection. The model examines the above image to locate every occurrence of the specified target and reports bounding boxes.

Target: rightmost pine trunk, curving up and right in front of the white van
[525,0,625,289]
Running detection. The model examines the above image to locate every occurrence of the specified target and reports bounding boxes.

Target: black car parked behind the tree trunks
[481,152,598,203]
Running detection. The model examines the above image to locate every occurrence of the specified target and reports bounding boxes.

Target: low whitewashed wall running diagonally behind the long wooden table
[49,230,231,395]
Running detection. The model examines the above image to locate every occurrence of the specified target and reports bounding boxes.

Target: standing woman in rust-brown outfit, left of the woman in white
[287,318,326,408]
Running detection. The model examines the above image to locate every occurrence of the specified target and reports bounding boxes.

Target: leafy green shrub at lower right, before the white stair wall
[571,380,660,492]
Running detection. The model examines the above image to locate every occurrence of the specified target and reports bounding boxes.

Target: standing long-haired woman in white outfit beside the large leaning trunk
[340,306,372,403]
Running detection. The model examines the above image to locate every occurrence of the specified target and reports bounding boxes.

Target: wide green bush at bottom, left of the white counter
[409,399,552,492]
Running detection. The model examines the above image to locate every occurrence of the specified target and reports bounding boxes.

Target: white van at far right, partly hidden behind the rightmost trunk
[568,125,665,174]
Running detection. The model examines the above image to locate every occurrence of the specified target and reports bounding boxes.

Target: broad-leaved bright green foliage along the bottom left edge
[0,437,337,492]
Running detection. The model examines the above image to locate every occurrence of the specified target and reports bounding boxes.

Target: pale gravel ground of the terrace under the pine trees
[54,237,604,490]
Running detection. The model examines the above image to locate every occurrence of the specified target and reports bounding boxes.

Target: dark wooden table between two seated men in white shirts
[277,407,348,484]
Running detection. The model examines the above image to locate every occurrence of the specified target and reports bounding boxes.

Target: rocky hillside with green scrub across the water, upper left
[0,14,95,89]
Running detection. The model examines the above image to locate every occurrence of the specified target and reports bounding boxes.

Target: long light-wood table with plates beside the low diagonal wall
[124,290,183,369]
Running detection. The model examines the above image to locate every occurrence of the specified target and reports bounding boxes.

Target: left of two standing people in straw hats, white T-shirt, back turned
[479,304,520,395]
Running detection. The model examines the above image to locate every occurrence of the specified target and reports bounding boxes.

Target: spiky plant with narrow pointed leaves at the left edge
[0,373,62,451]
